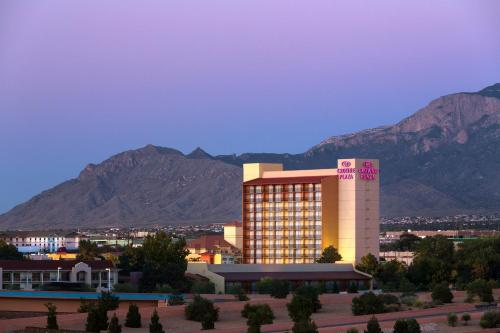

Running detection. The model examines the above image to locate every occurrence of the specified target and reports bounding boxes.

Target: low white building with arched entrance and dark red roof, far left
[0,260,118,290]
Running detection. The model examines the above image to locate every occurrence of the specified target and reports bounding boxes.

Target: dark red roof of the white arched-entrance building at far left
[0,260,115,271]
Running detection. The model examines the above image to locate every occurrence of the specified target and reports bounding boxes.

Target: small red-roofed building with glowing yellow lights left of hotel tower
[186,235,241,264]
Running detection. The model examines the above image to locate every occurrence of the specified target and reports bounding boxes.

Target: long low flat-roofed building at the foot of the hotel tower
[187,262,372,293]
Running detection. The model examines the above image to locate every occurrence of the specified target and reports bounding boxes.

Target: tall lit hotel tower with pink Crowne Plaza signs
[242,159,380,264]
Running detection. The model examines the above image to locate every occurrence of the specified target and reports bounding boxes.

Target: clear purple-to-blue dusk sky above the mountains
[0,0,500,212]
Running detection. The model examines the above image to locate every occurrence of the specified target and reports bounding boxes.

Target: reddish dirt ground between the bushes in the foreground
[0,290,500,333]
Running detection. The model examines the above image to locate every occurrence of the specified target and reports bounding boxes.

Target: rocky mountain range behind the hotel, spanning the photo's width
[0,83,500,229]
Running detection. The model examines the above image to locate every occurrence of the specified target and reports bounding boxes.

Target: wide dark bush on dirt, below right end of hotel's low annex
[351,292,401,316]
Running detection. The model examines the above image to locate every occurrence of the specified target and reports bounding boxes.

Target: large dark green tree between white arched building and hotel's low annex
[140,231,189,291]
